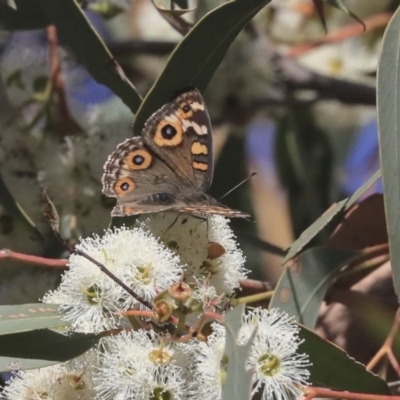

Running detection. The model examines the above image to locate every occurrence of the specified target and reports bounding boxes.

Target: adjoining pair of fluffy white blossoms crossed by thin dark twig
[43,227,182,333]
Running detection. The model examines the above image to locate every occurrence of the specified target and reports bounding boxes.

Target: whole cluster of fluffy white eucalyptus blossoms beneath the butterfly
[4,213,309,400]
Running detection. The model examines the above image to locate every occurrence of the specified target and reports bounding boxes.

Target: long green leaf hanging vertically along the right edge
[377,8,400,299]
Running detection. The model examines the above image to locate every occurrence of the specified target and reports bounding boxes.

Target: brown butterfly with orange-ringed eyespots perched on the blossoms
[102,88,249,218]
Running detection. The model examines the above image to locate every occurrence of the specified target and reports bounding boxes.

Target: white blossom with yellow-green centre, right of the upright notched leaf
[239,309,311,400]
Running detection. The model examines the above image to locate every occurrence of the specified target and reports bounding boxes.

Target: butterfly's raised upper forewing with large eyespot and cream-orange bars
[142,89,214,192]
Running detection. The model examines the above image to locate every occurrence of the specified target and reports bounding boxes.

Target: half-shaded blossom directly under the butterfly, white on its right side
[139,212,247,296]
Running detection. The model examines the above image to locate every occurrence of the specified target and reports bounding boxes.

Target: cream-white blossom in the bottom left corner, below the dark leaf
[1,351,97,400]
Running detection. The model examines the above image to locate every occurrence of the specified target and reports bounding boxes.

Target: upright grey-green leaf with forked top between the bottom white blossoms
[222,305,253,400]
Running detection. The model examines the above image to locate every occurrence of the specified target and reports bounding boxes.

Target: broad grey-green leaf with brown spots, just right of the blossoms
[269,247,360,328]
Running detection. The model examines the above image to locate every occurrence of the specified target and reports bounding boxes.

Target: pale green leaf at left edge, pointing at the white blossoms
[0,303,68,335]
